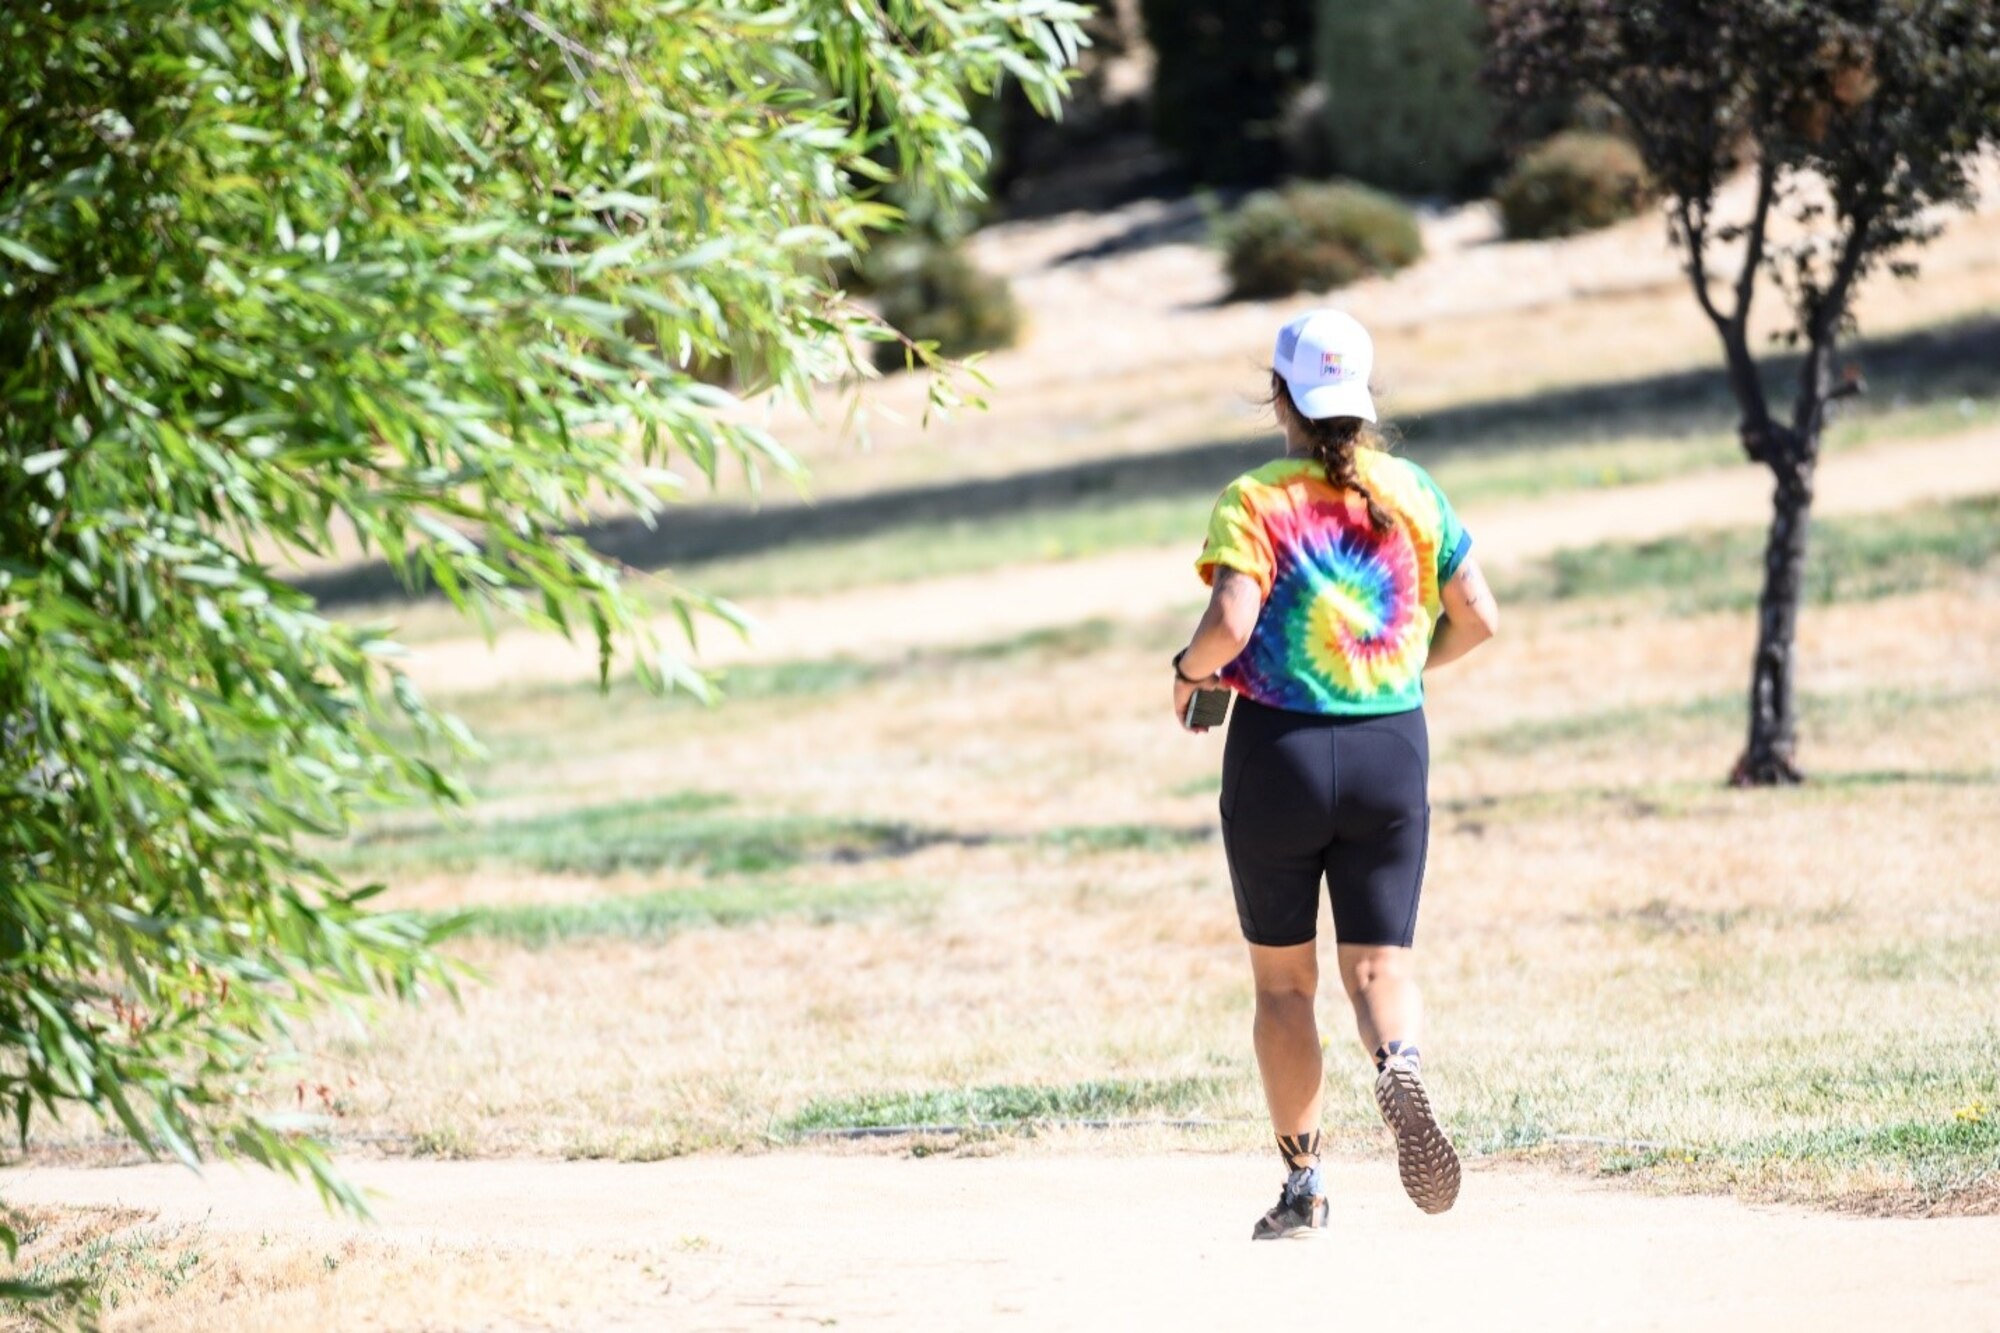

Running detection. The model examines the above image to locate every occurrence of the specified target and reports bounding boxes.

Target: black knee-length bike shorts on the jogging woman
[1222,697,1430,949]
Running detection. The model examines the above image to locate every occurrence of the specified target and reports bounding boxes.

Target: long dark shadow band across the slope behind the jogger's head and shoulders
[294,316,2000,606]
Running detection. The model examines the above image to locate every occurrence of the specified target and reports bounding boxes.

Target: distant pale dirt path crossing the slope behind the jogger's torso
[410,430,2000,695]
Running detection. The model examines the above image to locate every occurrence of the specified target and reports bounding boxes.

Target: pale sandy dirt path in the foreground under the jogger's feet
[4,1155,2000,1333]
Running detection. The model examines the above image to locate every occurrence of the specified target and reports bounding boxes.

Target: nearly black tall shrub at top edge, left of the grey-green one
[1140,0,1316,184]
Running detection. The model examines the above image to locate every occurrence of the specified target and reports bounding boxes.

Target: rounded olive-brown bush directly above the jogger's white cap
[1222,182,1424,296]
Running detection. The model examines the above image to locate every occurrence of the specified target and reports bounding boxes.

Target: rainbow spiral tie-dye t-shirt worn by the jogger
[1196,448,1472,715]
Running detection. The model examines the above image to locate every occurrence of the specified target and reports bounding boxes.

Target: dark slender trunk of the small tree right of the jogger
[1730,432,1820,787]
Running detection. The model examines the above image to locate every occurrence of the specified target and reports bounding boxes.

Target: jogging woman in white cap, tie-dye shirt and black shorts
[1174,310,1498,1239]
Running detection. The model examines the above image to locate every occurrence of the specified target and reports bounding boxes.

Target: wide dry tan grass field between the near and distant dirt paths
[101,560,1976,1209]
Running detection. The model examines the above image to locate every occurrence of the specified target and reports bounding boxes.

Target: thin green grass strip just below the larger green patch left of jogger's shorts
[430,883,918,949]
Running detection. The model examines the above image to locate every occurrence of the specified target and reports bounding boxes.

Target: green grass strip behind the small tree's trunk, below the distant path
[1498,496,2000,614]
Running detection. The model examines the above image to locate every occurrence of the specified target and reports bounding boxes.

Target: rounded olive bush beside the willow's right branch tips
[862,240,1020,370]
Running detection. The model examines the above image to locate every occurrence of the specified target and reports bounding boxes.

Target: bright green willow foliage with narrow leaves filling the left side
[0,0,1084,1272]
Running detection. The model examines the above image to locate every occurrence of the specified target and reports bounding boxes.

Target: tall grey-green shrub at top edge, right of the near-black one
[1318,0,1500,198]
